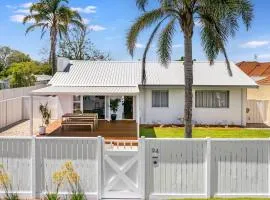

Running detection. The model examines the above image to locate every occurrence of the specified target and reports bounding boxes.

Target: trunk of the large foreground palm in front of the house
[184,35,193,138]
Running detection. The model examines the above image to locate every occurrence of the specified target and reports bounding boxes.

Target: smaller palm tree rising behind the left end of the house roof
[23,0,83,74]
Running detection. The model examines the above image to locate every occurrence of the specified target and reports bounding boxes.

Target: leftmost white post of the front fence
[31,136,37,199]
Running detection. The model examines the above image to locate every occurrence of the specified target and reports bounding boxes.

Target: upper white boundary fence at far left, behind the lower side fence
[0,84,46,101]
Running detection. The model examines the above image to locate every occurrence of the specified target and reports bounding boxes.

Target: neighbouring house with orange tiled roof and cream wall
[237,61,270,100]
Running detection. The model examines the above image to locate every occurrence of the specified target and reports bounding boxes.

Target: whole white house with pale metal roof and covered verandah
[33,58,257,136]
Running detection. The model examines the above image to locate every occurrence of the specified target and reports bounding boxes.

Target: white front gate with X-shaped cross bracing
[101,140,144,199]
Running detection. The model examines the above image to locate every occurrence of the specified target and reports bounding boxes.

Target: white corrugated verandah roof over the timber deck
[32,86,139,95]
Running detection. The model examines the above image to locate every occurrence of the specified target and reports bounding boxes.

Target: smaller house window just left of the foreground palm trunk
[152,90,169,107]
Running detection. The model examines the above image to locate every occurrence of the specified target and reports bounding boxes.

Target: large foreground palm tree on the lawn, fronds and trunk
[127,0,253,138]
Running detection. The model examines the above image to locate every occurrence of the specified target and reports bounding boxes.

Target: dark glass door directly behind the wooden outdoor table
[83,96,105,119]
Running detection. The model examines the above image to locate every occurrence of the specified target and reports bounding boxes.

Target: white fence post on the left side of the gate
[97,136,103,199]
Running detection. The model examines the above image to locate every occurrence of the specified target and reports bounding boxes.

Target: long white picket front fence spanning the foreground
[0,137,270,199]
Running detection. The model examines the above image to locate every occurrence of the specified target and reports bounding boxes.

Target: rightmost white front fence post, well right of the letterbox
[205,138,212,198]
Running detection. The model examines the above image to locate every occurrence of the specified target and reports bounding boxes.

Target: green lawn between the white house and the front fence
[141,127,270,138]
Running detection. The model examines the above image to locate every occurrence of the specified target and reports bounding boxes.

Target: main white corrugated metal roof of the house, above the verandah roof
[49,61,257,87]
